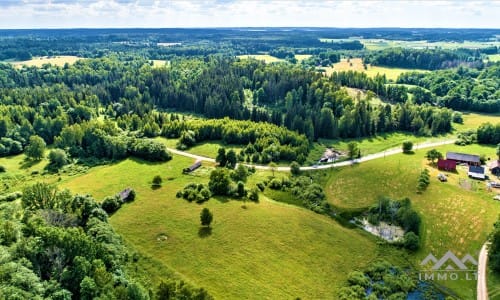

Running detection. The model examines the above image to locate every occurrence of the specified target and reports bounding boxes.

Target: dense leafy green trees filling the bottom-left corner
[0,183,212,300]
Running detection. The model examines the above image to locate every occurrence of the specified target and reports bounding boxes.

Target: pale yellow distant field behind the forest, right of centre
[323,58,427,81]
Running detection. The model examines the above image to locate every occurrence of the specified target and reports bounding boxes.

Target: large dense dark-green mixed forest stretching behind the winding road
[0,57,451,162]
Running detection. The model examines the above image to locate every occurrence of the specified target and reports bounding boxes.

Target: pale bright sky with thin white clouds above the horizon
[0,0,500,29]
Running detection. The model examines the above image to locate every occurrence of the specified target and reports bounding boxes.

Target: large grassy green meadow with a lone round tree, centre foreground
[61,156,401,299]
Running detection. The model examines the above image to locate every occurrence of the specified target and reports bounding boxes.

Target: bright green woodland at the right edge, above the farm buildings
[397,63,500,112]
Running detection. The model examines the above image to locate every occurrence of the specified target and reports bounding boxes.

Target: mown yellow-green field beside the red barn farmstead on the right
[325,145,500,299]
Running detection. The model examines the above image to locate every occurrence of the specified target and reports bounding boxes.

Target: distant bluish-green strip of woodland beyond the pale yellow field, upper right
[363,48,482,70]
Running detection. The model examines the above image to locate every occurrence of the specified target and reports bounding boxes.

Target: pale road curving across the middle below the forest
[167,140,455,171]
